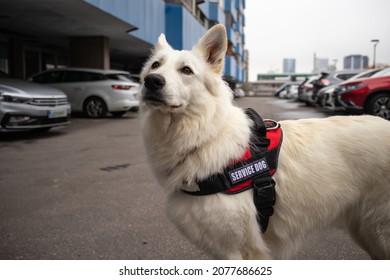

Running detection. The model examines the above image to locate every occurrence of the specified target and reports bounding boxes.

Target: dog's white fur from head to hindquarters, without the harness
[141,25,390,259]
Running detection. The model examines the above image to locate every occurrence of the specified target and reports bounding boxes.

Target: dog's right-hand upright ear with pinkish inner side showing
[194,24,227,74]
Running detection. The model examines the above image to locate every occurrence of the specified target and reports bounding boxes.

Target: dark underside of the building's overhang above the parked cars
[0,0,151,69]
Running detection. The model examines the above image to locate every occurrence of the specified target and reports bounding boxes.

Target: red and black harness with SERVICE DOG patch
[183,108,283,233]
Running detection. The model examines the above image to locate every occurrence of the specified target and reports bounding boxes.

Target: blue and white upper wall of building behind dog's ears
[84,0,247,82]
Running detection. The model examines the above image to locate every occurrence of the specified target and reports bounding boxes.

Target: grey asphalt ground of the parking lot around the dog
[0,97,368,260]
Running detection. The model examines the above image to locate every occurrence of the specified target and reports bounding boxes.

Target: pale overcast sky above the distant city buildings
[245,0,390,81]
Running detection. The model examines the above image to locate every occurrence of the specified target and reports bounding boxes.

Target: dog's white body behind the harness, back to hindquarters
[266,116,390,258]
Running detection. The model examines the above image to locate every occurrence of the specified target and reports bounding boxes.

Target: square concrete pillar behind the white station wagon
[69,36,110,70]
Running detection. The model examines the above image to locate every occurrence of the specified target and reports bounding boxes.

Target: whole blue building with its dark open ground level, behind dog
[0,0,247,83]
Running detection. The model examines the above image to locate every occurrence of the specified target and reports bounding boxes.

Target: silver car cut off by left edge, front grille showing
[0,78,71,131]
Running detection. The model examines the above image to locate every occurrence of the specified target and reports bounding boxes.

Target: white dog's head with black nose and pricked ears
[141,24,227,113]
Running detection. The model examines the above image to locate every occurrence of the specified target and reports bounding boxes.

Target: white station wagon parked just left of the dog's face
[30,68,140,118]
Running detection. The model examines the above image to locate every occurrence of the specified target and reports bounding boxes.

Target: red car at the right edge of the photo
[335,68,390,120]
